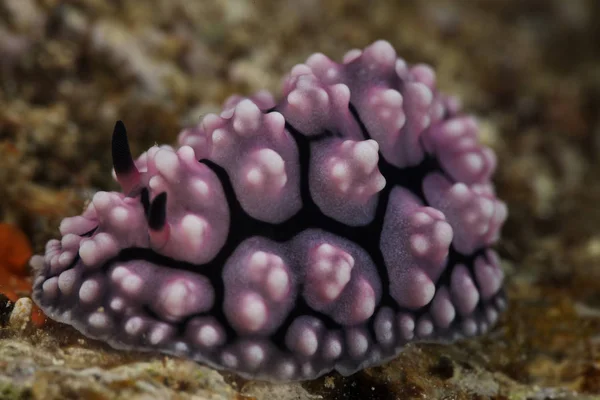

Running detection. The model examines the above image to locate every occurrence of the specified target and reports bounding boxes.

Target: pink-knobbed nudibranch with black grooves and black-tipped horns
[31,41,507,381]
